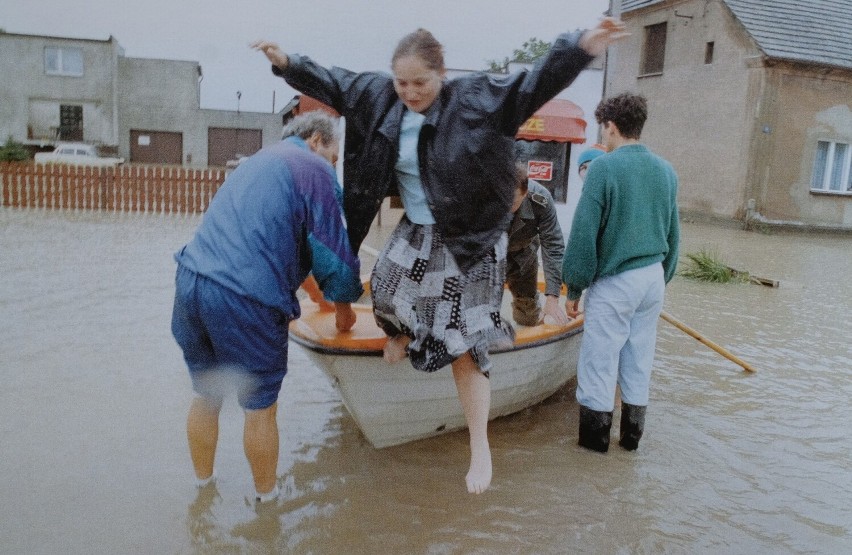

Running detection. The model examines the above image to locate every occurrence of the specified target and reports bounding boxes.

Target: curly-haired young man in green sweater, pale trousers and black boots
[562,93,680,453]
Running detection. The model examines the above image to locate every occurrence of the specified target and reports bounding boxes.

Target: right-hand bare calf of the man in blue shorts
[243,403,278,494]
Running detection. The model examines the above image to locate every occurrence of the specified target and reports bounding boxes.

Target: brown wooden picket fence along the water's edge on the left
[0,162,225,214]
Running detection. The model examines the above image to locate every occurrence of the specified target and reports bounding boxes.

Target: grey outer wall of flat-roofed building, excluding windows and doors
[0,33,282,167]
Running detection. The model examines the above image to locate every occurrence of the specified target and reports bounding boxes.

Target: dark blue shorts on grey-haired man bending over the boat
[172,265,289,410]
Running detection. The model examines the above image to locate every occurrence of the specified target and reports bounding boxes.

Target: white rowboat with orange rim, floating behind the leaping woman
[290,295,583,448]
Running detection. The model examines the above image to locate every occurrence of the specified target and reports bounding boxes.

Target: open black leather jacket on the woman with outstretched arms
[272,32,592,270]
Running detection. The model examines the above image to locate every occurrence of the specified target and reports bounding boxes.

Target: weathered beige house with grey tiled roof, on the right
[605,0,852,229]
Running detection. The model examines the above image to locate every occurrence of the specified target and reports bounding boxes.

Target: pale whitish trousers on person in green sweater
[577,263,665,412]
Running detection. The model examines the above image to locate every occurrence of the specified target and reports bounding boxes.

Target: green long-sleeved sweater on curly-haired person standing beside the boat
[562,144,680,300]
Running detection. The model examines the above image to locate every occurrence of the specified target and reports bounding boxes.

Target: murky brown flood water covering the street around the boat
[0,208,852,554]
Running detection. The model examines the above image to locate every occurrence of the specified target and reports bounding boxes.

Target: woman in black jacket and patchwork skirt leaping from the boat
[252,18,627,493]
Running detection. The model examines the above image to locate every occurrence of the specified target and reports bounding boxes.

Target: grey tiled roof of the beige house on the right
[621,0,852,69]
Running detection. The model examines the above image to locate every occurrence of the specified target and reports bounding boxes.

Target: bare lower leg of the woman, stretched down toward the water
[453,353,491,493]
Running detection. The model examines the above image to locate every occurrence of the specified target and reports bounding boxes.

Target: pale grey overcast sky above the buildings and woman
[0,0,609,112]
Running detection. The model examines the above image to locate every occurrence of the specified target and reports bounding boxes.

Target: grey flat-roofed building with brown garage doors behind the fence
[0,32,282,167]
